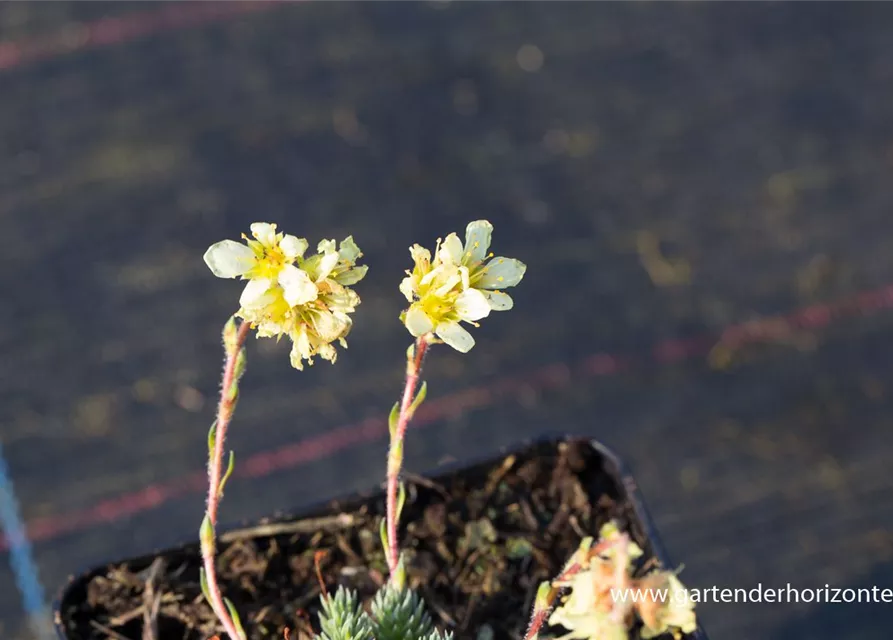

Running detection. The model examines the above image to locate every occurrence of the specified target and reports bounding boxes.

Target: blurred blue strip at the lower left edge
[0,443,52,640]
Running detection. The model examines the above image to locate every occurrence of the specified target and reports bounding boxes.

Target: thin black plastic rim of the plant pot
[54,436,708,640]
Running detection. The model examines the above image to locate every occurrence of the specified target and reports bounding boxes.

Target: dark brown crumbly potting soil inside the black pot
[59,442,684,640]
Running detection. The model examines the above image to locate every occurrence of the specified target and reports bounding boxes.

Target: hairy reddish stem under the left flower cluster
[201,322,251,640]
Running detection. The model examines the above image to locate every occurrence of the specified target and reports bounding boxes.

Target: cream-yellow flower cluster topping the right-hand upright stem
[400,220,527,353]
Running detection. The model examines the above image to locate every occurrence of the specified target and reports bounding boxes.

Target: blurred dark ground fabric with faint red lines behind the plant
[0,0,893,640]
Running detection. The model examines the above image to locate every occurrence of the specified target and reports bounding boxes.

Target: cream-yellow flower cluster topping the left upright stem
[204,222,367,369]
